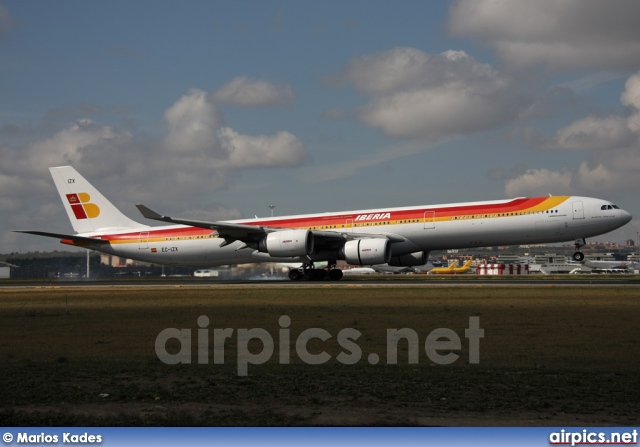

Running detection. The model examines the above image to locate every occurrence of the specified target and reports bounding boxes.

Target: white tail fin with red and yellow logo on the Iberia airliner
[49,166,145,233]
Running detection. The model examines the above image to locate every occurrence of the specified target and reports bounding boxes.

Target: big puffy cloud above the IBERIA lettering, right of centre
[342,48,530,141]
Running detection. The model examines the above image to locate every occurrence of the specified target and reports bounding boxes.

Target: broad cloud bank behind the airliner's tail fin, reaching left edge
[0,85,308,251]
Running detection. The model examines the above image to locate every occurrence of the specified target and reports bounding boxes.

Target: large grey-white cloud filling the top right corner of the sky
[448,0,640,71]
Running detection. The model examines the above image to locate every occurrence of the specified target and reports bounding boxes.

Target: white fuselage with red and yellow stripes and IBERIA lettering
[72,196,631,266]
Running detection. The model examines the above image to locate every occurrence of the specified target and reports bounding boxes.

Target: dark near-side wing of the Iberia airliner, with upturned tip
[136,204,406,247]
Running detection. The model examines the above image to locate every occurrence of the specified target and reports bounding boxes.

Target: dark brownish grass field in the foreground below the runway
[0,285,640,425]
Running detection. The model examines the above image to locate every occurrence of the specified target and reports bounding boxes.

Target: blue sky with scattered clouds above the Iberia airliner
[0,0,640,253]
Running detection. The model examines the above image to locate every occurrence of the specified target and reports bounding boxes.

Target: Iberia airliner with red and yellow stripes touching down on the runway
[18,166,631,280]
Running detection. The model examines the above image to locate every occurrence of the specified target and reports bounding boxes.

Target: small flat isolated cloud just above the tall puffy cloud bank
[212,76,295,107]
